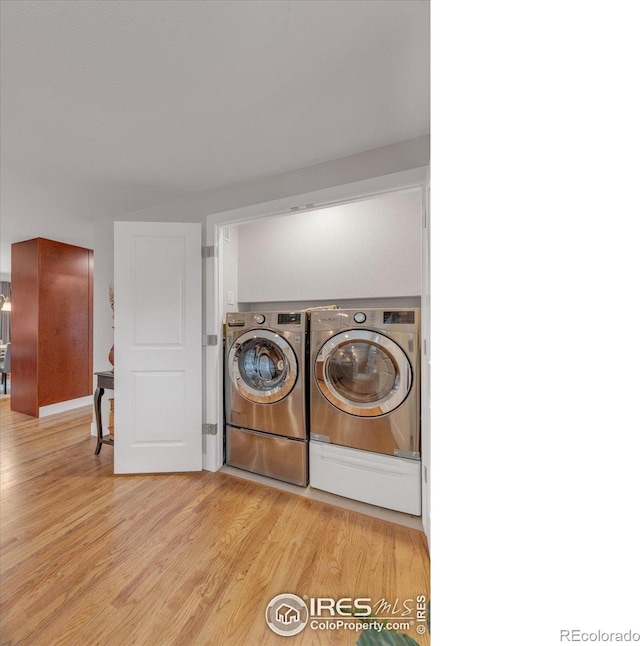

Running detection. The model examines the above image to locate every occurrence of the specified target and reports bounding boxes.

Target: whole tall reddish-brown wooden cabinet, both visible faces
[11,238,93,417]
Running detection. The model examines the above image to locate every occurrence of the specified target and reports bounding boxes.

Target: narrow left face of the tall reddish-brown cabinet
[11,239,38,417]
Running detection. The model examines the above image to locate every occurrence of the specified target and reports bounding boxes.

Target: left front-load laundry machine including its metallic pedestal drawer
[225,312,309,486]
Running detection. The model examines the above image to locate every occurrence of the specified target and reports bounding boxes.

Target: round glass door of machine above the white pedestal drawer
[315,330,413,417]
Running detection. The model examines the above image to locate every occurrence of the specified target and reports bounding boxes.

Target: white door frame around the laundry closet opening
[203,166,431,539]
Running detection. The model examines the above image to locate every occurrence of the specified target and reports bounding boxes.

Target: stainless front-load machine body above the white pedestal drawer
[310,308,420,459]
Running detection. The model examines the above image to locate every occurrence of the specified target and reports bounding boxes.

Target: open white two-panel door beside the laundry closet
[114,222,202,473]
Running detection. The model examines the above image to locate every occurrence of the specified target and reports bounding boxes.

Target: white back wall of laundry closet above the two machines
[238,189,422,303]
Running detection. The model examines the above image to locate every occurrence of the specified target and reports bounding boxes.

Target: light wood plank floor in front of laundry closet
[0,397,430,646]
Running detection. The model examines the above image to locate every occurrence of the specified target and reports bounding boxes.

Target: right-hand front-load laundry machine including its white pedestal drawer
[309,308,421,515]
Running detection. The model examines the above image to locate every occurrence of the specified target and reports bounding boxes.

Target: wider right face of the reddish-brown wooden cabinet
[38,240,93,406]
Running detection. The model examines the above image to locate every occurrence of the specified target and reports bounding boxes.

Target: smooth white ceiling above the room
[0,0,429,271]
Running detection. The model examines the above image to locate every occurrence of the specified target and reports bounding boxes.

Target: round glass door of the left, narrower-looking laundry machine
[228,330,298,404]
